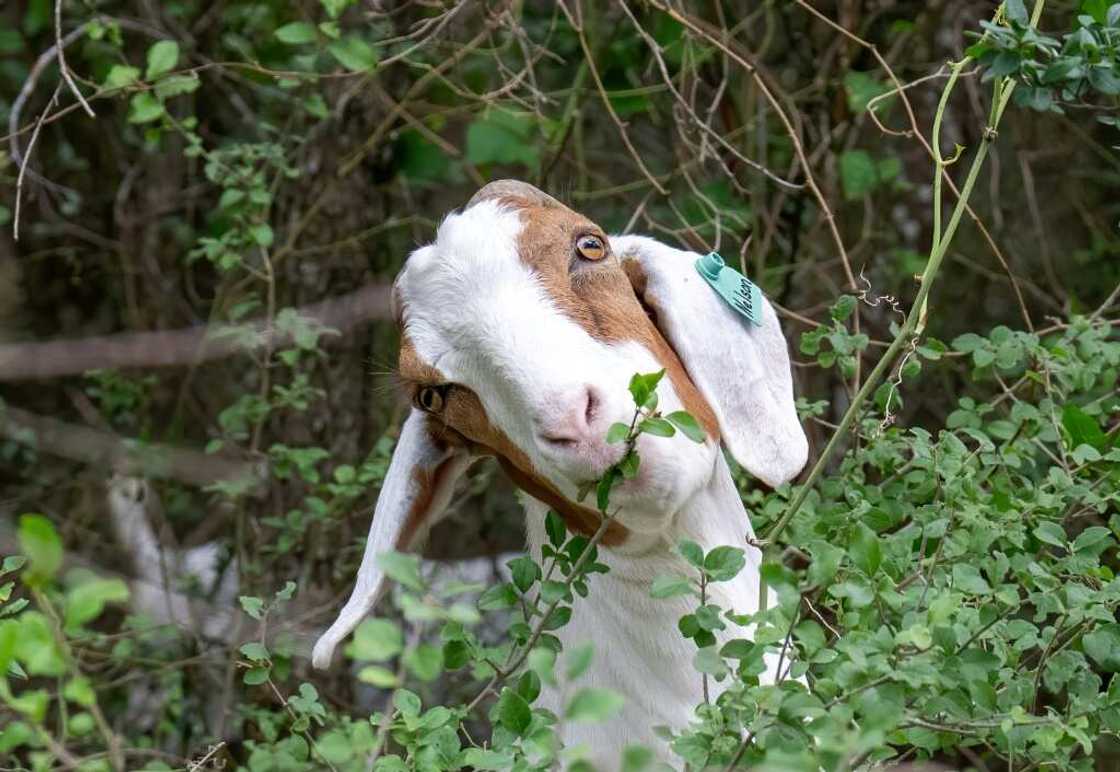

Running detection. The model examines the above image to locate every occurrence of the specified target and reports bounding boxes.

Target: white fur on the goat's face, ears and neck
[315,193,808,769]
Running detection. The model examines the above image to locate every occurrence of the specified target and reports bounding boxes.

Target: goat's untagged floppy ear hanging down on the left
[311,410,470,669]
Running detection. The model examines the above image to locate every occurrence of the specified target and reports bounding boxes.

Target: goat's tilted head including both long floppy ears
[312,182,808,667]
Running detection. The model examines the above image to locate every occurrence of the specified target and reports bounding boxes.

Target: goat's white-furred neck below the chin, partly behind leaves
[526,457,760,769]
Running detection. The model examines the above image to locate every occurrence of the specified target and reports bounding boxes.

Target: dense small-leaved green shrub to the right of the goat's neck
[654,318,1120,769]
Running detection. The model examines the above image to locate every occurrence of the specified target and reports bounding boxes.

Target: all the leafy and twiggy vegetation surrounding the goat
[0,0,1120,770]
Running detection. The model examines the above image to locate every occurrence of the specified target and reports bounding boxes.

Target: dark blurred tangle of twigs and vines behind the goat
[0,0,1120,766]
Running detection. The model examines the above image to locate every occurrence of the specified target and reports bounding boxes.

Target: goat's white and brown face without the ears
[395,186,719,540]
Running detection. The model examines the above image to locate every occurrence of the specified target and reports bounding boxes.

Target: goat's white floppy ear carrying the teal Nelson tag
[610,236,809,486]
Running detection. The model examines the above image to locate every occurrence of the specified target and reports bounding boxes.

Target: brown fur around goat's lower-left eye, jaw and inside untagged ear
[399,334,629,547]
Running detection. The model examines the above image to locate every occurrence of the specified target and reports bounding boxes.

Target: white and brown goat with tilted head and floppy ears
[312,180,809,766]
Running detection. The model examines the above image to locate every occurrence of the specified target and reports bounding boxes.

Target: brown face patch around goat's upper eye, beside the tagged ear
[508,202,719,439]
